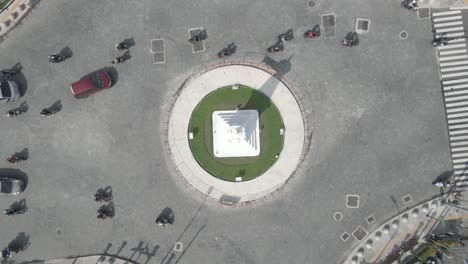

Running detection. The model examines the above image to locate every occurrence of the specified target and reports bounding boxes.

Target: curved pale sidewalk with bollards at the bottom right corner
[343,194,468,264]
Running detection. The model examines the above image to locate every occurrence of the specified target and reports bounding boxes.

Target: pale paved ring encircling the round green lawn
[167,64,306,204]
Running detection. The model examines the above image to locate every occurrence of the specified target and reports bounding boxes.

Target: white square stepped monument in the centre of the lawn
[212,110,260,158]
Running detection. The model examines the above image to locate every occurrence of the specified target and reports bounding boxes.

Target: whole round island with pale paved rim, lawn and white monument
[167,64,308,205]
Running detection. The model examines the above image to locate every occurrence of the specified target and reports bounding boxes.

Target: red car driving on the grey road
[71,71,112,98]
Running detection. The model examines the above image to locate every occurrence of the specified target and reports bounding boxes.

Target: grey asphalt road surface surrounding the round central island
[0,0,451,264]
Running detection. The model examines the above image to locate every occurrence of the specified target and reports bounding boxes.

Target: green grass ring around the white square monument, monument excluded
[188,85,284,181]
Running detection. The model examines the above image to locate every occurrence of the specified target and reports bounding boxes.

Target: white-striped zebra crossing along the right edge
[432,10,468,190]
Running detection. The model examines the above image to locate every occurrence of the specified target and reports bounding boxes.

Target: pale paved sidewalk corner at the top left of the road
[0,0,39,38]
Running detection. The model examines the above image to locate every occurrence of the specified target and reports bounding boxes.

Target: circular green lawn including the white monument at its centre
[188,85,284,182]
